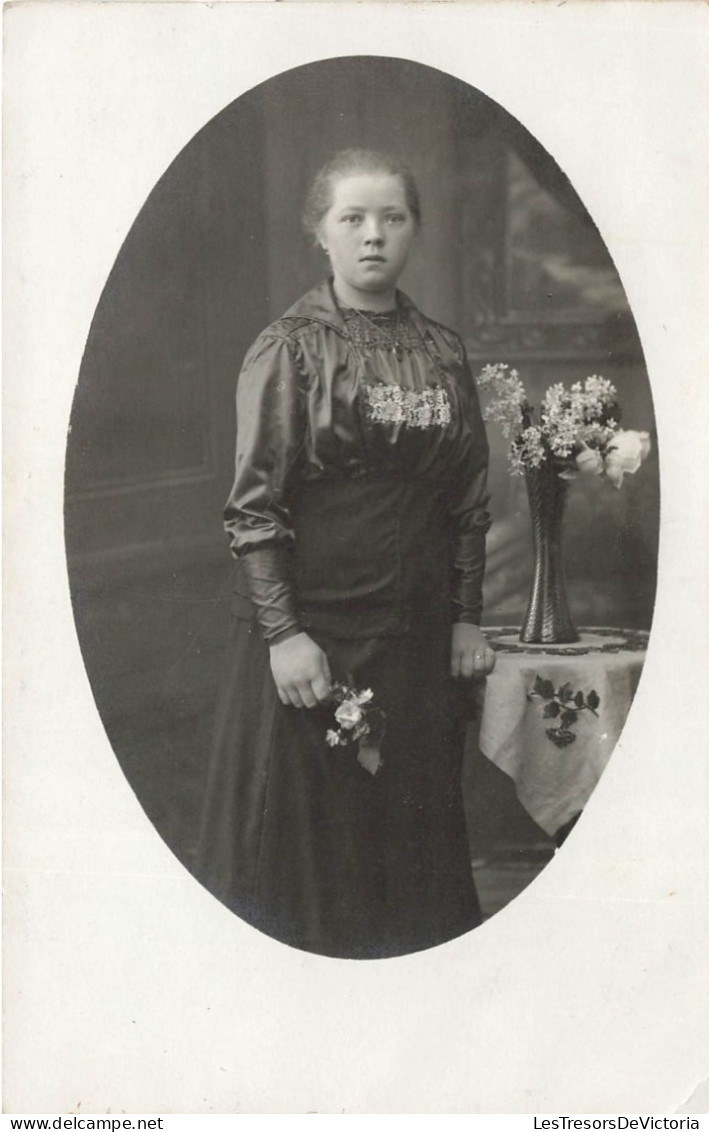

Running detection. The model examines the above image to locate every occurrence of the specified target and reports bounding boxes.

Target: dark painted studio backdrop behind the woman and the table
[66,57,658,882]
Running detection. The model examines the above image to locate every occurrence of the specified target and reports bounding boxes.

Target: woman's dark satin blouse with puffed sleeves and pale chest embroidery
[225,284,489,635]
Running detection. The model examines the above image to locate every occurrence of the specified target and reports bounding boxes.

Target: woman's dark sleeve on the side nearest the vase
[449,340,490,625]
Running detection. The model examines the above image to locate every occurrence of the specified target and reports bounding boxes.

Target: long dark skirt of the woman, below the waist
[197,620,480,959]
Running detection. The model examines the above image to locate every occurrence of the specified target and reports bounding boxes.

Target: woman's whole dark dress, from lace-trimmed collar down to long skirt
[197,283,489,959]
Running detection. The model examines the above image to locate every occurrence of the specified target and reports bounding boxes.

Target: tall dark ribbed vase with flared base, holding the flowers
[520,461,579,644]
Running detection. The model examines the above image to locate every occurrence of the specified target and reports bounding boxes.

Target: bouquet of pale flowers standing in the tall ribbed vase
[478,362,650,488]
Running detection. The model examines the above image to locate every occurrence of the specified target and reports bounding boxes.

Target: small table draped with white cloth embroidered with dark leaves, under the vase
[479,627,648,837]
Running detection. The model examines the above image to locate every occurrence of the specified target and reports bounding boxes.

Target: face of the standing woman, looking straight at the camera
[318,173,416,306]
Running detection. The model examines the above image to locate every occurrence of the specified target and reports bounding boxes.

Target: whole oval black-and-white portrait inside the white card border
[66,57,659,959]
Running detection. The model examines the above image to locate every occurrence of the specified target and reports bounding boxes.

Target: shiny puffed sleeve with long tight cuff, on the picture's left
[224,331,305,644]
